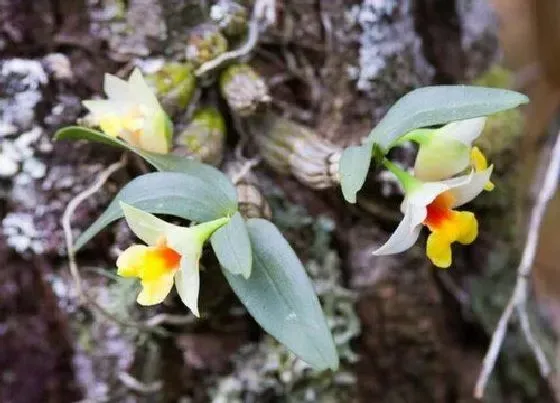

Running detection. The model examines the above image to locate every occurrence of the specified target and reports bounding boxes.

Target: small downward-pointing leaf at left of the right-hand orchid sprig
[339,144,371,203]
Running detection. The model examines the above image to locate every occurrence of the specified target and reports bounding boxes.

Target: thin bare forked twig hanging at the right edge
[474,133,560,399]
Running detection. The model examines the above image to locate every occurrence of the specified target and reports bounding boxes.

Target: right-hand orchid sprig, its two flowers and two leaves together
[340,86,528,268]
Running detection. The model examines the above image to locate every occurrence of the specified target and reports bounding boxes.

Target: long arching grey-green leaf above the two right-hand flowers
[368,85,529,150]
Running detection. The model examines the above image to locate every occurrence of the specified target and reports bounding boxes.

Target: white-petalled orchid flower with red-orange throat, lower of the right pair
[373,161,492,268]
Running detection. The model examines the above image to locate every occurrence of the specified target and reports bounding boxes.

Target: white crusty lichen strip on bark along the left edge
[0,59,57,254]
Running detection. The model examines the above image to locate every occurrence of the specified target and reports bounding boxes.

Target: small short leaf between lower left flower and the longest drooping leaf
[210,212,252,278]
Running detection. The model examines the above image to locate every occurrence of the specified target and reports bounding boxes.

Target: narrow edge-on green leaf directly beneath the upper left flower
[54,126,233,189]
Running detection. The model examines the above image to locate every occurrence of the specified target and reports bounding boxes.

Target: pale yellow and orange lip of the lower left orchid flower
[117,238,181,305]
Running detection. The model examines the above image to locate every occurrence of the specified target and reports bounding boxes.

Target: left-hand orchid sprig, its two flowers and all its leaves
[65,70,338,370]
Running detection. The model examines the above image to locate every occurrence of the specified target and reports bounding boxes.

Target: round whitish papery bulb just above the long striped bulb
[220,64,270,117]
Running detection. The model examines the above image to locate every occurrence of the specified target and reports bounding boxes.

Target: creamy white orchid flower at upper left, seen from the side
[82,69,172,154]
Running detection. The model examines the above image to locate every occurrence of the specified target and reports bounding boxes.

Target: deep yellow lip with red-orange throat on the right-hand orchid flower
[424,192,478,268]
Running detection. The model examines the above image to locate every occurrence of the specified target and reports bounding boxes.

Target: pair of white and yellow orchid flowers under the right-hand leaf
[373,117,494,268]
